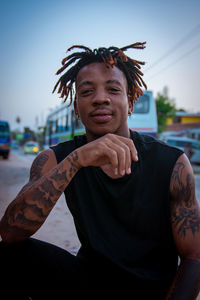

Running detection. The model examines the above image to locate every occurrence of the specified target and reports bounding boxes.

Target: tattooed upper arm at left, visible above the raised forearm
[30,149,57,181]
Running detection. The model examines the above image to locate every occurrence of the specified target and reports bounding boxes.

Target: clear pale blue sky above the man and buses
[0,0,200,130]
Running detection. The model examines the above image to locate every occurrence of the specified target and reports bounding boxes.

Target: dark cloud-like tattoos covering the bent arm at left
[0,151,79,242]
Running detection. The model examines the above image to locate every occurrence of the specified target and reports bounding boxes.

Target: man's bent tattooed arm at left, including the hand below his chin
[0,134,138,243]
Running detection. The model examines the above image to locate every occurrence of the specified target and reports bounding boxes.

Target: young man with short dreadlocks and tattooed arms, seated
[0,43,200,300]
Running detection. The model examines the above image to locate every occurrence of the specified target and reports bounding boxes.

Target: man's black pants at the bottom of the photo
[0,239,169,300]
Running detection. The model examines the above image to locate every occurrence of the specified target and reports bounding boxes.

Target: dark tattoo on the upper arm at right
[172,162,200,238]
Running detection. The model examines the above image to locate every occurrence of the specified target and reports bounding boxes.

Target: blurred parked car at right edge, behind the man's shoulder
[165,136,200,164]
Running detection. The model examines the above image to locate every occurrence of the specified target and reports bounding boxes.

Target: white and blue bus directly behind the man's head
[45,91,158,148]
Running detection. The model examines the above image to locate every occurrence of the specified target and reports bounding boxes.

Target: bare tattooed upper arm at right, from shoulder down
[170,154,200,259]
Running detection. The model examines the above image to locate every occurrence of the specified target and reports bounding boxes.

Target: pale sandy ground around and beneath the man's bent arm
[0,150,200,300]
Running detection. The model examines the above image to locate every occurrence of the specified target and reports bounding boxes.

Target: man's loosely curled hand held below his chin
[77,133,138,176]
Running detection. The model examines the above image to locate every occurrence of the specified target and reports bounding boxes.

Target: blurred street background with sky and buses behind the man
[0,0,200,248]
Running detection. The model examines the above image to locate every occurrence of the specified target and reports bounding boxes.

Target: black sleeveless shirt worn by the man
[52,131,183,281]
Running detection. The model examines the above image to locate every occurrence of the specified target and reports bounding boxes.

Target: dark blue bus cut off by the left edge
[0,121,11,159]
